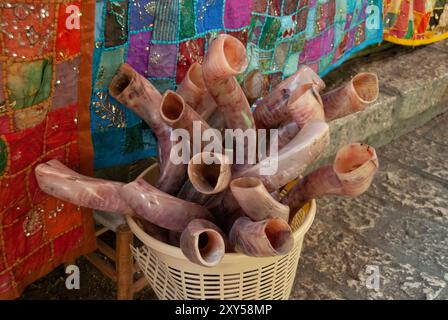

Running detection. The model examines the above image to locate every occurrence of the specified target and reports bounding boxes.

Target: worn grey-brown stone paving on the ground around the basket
[22,113,448,299]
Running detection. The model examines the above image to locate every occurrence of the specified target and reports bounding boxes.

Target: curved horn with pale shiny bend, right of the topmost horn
[254,66,325,129]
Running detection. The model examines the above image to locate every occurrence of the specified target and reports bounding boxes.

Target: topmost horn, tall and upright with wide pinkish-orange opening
[202,34,255,130]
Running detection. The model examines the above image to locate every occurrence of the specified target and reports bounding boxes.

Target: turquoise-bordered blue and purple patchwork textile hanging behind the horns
[91,0,382,168]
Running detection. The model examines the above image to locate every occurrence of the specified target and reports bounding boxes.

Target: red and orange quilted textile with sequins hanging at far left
[0,0,94,299]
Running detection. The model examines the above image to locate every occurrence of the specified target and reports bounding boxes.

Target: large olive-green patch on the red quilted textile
[6,59,53,110]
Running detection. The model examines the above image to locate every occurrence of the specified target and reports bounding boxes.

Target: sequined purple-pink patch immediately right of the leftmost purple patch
[148,44,177,78]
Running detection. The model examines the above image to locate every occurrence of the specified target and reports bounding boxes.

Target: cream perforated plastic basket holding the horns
[127,165,316,300]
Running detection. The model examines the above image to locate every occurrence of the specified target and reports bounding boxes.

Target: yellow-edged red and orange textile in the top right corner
[383,0,448,46]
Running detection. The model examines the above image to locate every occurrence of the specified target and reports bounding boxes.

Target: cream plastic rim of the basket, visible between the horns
[126,199,316,262]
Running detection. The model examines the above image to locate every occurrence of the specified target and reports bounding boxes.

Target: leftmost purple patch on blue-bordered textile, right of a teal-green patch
[126,31,152,77]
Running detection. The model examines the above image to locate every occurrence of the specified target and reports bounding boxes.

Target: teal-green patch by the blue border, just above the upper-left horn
[95,48,124,89]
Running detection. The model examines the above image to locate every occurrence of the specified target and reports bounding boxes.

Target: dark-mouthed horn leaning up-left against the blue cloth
[109,63,171,171]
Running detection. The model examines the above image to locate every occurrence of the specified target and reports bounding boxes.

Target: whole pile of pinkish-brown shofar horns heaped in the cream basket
[36,34,378,267]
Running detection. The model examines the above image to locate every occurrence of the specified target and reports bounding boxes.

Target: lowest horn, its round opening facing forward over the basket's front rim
[180,219,226,267]
